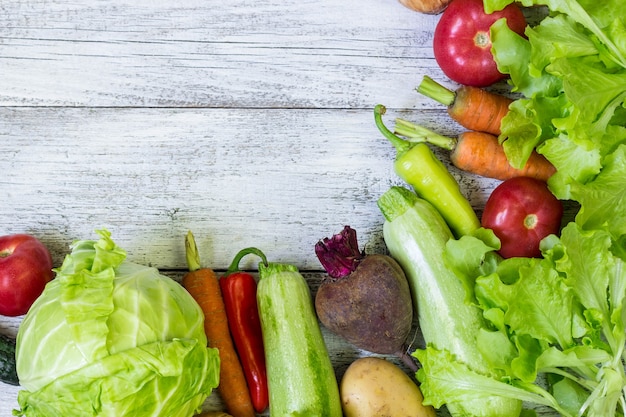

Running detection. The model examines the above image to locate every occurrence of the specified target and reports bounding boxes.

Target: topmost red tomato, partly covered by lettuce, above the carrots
[433,0,526,87]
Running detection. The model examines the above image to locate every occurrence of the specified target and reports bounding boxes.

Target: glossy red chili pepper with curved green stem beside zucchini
[219,248,269,413]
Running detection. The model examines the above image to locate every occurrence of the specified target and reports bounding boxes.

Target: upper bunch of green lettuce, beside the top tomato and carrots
[485,0,626,229]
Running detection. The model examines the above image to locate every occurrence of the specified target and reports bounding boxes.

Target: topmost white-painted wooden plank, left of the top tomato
[0,0,441,108]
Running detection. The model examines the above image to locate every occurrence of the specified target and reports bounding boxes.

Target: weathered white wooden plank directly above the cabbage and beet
[0,108,496,270]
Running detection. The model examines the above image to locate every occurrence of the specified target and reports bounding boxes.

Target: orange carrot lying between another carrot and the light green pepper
[395,119,556,181]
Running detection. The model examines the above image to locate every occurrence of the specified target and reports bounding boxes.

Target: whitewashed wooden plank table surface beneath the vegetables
[0,0,550,416]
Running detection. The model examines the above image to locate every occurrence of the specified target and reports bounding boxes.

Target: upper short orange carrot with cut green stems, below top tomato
[417,76,513,136]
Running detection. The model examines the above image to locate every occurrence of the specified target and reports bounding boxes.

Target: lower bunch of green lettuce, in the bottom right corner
[438,222,626,417]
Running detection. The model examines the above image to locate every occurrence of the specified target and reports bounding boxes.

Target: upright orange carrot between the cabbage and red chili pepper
[182,232,255,417]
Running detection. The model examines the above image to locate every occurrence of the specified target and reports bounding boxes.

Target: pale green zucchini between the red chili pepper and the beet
[257,263,342,417]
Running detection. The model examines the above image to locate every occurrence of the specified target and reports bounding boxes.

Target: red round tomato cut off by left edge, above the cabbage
[0,234,54,316]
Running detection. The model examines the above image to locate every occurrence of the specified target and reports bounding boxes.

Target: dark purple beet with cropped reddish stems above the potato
[315,226,417,371]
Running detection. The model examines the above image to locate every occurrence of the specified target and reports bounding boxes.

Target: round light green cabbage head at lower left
[13,230,219,417]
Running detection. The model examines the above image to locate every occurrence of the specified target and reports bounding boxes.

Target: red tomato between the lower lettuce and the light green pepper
[481,177,563,258]
